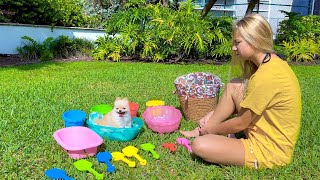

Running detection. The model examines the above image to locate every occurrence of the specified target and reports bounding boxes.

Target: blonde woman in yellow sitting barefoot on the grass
[180,14,301,168]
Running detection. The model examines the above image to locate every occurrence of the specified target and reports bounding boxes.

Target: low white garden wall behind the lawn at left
[0,23,105,54]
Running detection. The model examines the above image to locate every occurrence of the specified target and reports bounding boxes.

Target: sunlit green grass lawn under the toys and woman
[0,62,320,179]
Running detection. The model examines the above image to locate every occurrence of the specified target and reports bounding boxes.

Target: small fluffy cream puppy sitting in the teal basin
[95,97,132,128]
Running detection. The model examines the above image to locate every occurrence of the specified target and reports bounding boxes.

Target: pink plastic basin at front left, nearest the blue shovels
[53,126,103,159]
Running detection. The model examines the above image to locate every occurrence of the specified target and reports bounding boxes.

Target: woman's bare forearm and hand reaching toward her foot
[199,108,257,135]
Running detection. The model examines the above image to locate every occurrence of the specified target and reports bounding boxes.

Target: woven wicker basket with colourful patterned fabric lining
[174,72,222,122]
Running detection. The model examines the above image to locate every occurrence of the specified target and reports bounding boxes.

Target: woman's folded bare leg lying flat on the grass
[191,134,245,166]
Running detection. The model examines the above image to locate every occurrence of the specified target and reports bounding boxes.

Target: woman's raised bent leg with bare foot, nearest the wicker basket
[180,79,245,137]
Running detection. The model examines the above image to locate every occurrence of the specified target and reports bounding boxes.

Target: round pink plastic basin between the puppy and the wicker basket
[142,106,182,134]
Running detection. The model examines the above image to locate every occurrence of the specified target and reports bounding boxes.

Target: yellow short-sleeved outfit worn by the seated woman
[240,58,302,168]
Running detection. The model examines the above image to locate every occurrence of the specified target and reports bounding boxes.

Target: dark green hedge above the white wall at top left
[0,0,97,27]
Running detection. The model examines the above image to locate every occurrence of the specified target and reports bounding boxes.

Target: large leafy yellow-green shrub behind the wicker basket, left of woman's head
[93,0,232,61]
